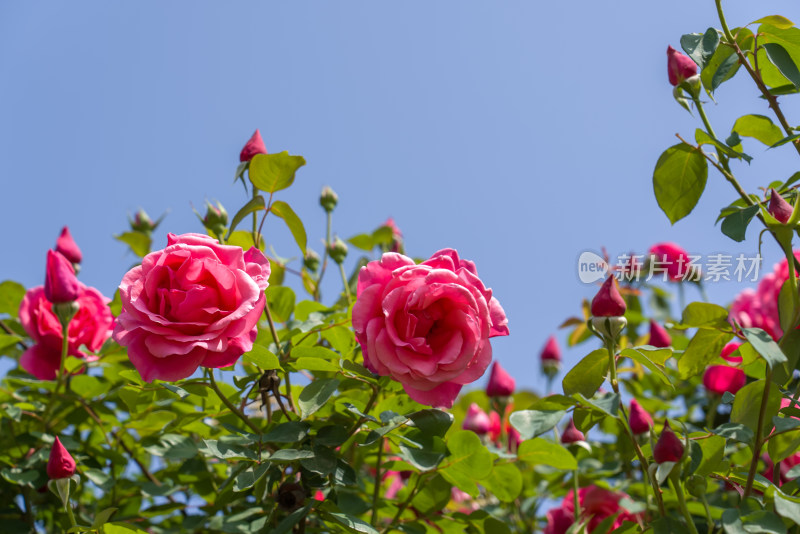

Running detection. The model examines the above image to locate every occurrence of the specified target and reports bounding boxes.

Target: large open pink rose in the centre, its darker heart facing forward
[353,249,508,408]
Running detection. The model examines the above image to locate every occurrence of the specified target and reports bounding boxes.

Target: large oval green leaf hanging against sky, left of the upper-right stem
[653,143,708,224]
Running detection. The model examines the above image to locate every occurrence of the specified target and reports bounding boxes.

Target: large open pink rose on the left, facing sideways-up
[114,234,270,382]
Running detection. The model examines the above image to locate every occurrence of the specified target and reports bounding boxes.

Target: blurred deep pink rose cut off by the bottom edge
[544,485,636,534]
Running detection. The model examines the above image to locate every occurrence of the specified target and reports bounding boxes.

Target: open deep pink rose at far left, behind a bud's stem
[19,280,114,380]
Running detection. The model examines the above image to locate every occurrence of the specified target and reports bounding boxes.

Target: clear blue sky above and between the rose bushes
[0,0,800,389]
